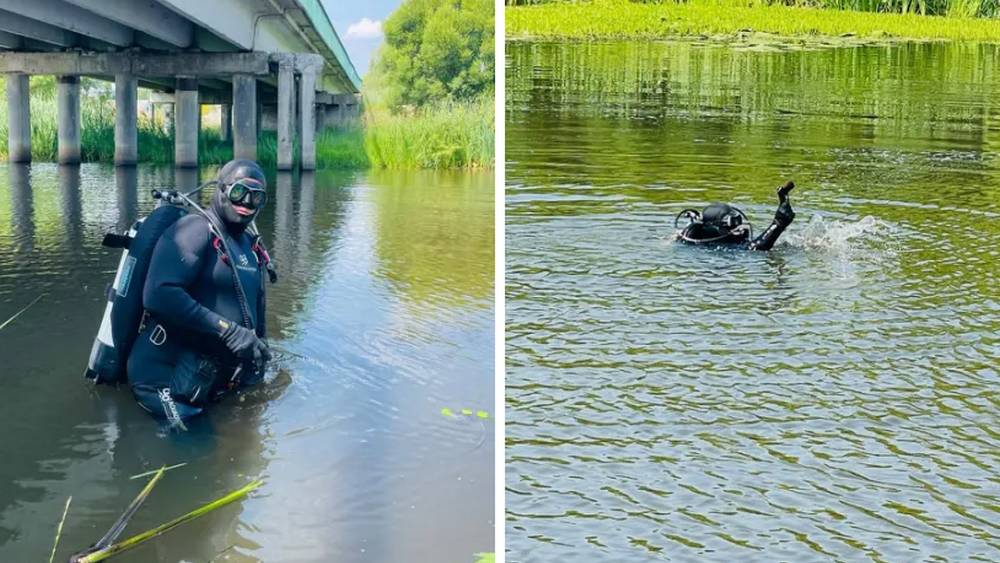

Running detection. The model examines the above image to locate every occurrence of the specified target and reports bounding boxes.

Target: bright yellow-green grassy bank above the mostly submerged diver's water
[505,0,1000,43]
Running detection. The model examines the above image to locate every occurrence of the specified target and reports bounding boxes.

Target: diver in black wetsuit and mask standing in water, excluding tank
[127,160,270,428]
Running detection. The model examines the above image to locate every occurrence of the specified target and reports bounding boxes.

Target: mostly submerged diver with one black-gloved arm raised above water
[674,181,795,250]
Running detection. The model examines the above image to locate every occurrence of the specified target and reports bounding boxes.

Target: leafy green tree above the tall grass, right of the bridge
[371,0,494,109]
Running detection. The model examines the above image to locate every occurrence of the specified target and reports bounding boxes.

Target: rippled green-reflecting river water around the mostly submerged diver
[506,42,1000,562]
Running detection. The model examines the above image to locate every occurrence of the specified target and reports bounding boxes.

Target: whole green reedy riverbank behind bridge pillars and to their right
[0,77,493,169]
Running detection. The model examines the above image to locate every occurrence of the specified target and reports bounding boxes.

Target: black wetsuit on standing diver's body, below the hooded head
[127,208,265,423]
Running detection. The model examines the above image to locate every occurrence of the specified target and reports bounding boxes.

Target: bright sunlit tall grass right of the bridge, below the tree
[364,95,494,168]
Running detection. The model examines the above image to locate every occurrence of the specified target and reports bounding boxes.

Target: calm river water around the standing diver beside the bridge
[0,164,495,562]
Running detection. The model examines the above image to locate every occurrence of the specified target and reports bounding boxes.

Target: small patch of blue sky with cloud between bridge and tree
[322,0,402,76]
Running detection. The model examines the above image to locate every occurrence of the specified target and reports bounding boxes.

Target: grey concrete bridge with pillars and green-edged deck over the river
[0,0,361,170]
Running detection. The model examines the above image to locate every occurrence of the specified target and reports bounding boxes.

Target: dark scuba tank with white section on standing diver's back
[84,200,187,385]
